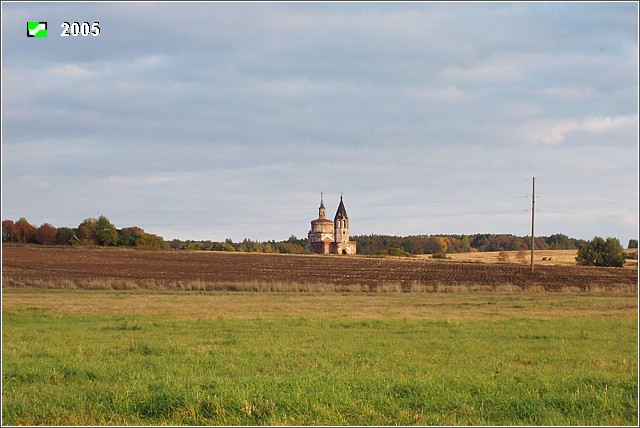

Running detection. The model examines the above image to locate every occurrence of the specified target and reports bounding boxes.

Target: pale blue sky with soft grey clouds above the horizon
[2,2,639,247]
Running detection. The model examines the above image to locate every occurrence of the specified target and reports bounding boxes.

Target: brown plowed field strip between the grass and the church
[2,246,638,291]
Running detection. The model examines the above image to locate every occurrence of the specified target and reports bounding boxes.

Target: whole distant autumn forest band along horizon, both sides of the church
[2,216,596,255]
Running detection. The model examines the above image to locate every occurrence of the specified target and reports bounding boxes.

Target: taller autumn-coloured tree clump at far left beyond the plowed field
[2,215,169,250]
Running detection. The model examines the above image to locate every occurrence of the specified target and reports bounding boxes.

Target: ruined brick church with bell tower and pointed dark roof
[307,194,356,255]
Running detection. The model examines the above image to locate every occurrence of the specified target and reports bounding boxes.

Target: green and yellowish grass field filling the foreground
[2,289,638,426]
